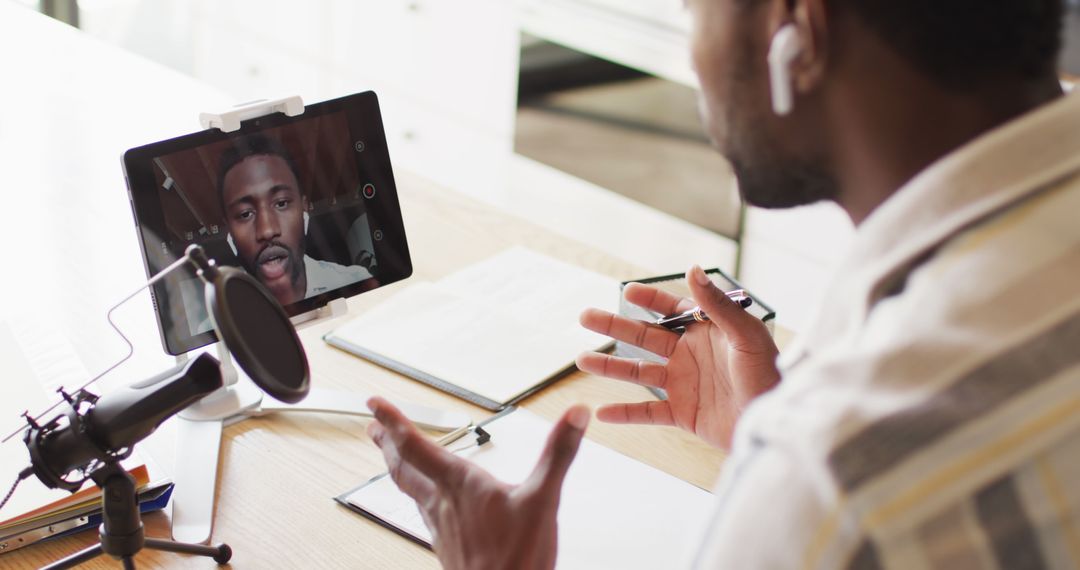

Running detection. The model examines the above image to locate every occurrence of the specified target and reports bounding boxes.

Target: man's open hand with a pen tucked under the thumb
[578,267,780,449]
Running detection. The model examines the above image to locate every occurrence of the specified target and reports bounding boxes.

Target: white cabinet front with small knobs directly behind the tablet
[80,0,519,200]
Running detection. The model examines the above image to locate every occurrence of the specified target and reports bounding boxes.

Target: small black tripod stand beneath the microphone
[44,461,232,570]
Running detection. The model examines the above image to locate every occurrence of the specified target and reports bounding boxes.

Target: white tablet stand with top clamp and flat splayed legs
[173,96,470,543]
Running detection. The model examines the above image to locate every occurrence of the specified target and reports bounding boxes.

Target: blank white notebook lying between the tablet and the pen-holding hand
[325,247,619,410]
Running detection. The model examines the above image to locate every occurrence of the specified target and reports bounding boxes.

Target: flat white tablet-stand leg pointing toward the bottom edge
[173,417,221,544]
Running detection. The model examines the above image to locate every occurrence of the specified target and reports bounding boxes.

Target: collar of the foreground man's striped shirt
[783,94,1080,366]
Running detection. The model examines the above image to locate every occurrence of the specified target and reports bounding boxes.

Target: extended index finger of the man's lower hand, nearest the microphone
[367,396,458,484]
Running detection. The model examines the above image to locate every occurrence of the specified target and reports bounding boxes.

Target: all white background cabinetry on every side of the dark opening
[80,0,851,329]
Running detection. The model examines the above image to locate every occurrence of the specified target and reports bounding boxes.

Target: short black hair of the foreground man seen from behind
[829,0,1064,90]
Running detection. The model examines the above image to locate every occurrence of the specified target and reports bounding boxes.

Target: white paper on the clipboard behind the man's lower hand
[337,409,713,569]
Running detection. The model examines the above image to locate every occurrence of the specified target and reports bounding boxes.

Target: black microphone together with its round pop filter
[12,245,311,494]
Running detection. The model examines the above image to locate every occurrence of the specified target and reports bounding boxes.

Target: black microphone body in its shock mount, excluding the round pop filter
[24,354,221,492]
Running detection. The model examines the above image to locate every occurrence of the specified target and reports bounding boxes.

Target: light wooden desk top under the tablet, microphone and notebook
[0,2,721,569]
